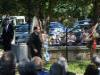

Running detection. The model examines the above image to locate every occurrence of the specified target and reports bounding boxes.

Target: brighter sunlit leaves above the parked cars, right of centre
[54,0,92,18]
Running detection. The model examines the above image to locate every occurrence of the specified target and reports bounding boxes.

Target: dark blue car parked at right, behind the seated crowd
[67,19,92,44]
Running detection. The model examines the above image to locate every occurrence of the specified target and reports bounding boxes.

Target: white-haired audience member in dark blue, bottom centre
[49,56,68,75]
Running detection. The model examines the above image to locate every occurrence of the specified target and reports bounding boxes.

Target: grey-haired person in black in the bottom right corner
[84,55,100,75]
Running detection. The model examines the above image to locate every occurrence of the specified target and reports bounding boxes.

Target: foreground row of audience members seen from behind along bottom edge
[0,51,100,75]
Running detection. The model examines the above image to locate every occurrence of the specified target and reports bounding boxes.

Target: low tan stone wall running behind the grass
[43,45,100,63]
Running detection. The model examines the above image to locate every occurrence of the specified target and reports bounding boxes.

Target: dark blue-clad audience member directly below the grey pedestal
[18,59,37,75]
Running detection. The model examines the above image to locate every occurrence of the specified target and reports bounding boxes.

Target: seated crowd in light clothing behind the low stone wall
[49,28,100,46]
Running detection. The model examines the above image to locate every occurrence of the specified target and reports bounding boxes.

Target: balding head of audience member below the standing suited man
[32,56,42,70]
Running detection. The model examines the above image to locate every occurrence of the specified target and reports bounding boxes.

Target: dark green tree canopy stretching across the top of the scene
[0,0,97,25]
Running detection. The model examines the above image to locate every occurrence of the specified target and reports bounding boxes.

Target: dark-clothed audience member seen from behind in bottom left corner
[0,51,16,75]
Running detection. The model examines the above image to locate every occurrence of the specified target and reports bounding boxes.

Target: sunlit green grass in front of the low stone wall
[44,60,90,75]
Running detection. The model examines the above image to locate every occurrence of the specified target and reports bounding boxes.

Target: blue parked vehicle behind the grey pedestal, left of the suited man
[15,24,29,43]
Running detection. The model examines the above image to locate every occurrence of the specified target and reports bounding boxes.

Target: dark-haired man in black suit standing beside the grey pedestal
[27,26,42,59]
